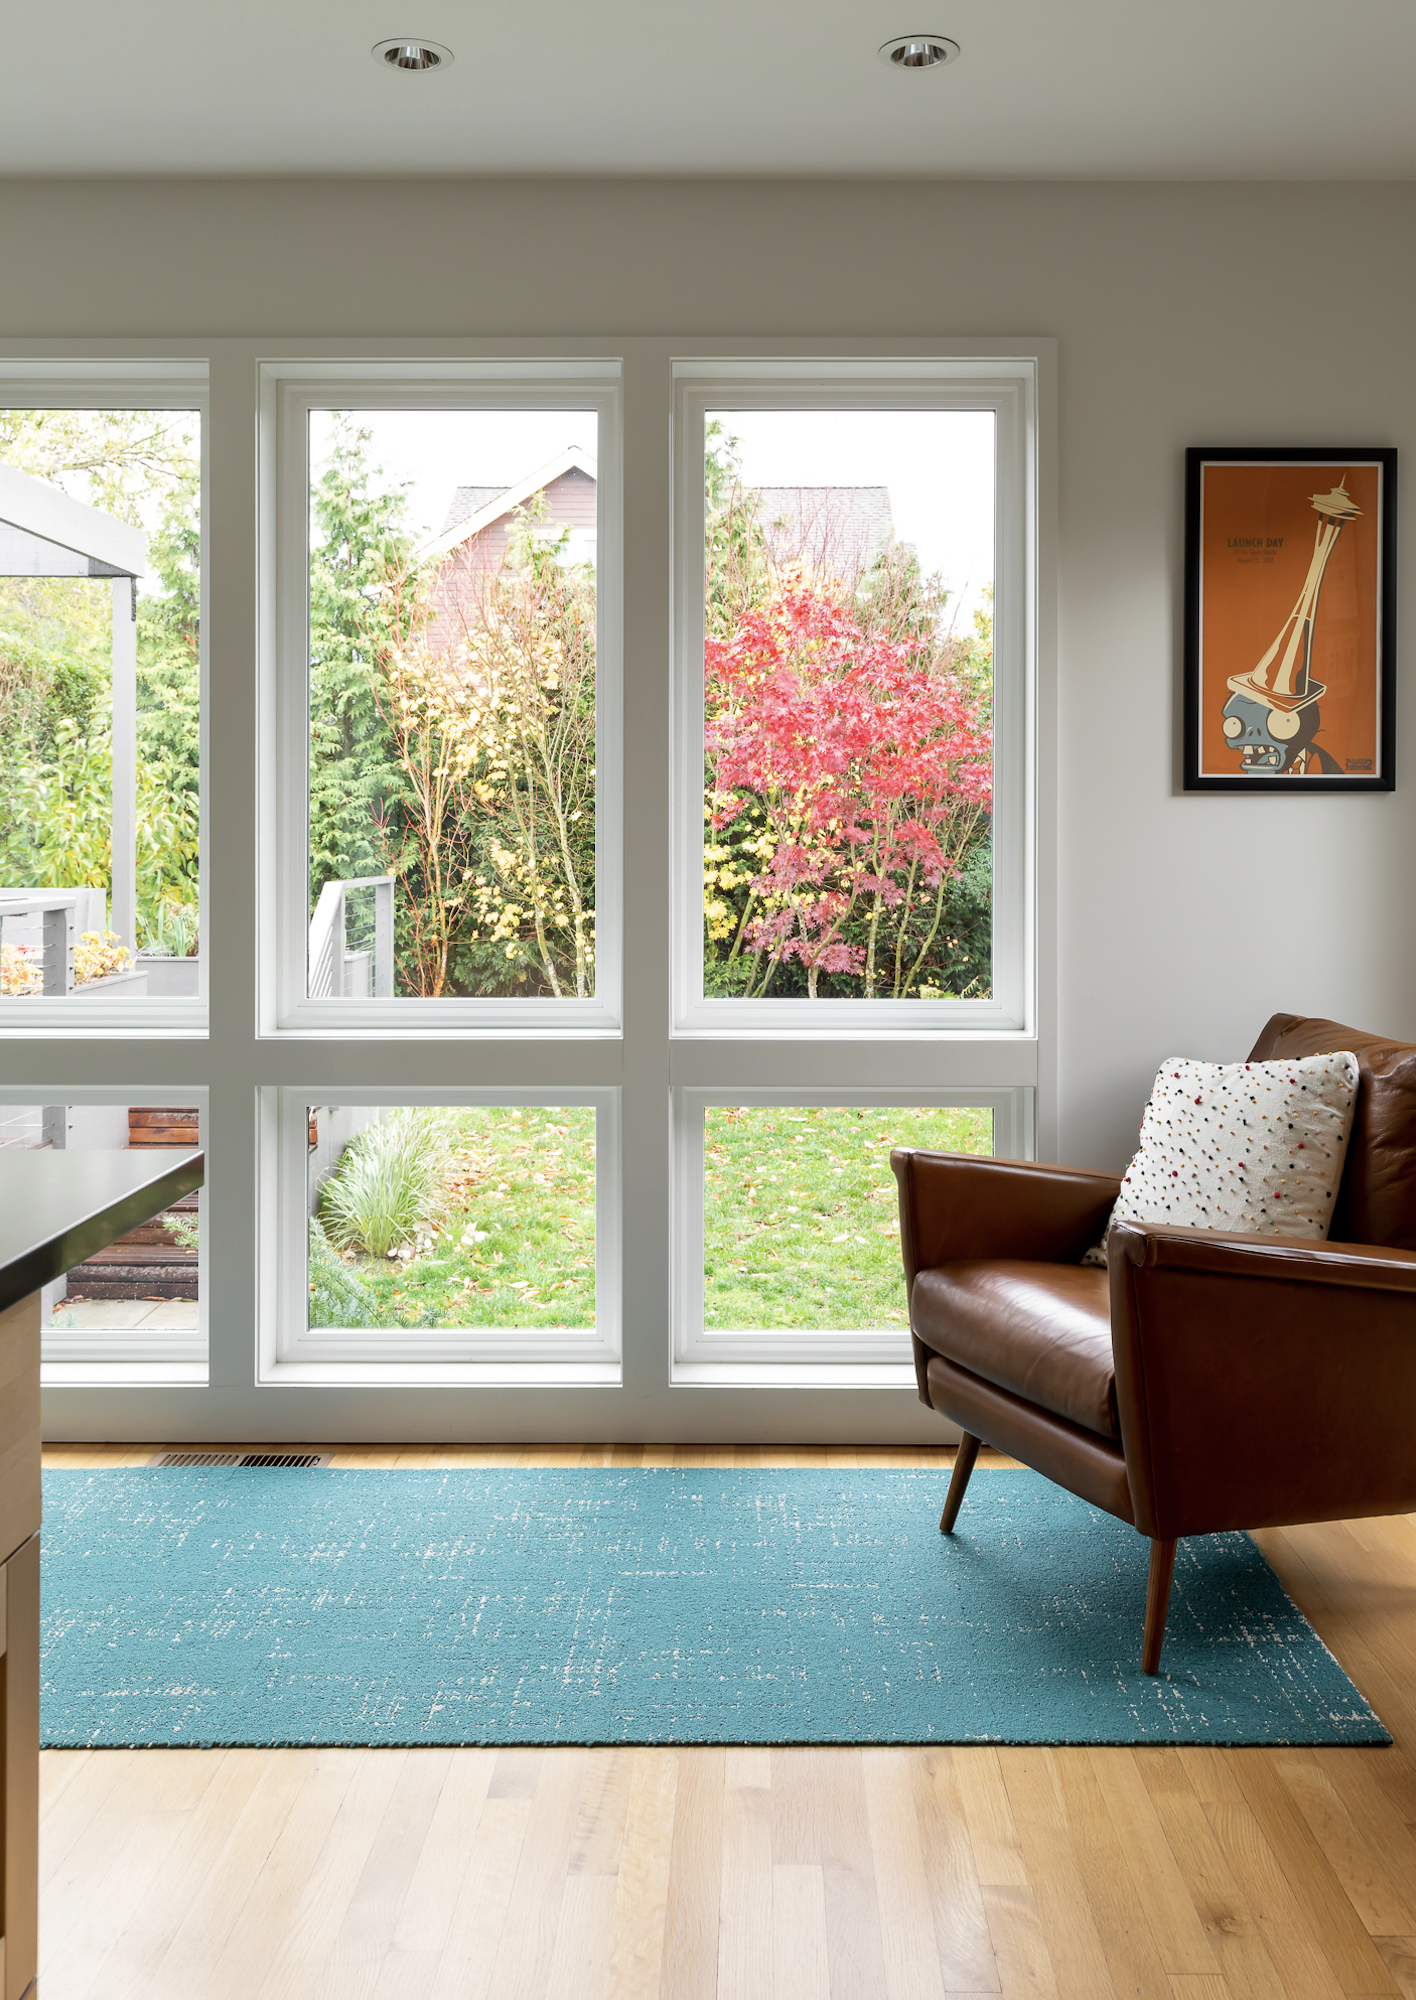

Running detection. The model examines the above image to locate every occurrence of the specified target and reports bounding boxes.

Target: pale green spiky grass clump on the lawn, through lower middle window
[320,1106,448,1256]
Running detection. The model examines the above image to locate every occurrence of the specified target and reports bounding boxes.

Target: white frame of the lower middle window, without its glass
[258,1082,622,1386]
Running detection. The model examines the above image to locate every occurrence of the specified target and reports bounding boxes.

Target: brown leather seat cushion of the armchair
[910,1258,1120,1442]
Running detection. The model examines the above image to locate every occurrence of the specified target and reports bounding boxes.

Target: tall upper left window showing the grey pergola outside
[0,366,204,1034]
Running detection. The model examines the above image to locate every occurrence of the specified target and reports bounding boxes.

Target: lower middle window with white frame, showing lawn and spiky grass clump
[266,1090,620,1380]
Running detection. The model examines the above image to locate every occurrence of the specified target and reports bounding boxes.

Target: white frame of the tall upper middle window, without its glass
[260,358,624,1040]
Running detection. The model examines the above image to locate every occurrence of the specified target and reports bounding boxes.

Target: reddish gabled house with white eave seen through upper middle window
[414,444,596,652]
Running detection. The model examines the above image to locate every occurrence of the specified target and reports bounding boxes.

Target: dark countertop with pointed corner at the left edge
[0,1146,206,1312]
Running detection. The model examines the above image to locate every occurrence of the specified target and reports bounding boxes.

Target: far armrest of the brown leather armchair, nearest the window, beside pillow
[890,1146,1120,1292]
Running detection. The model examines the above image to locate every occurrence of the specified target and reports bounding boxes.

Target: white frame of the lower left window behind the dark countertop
[0,1078,210,1388]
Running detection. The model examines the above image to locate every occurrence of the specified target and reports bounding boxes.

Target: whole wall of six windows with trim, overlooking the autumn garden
[11,336,1050,1438]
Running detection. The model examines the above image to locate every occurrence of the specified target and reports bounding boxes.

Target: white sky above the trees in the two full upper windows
[310,410,994,624]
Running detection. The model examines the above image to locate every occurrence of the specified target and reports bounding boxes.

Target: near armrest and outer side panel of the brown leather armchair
[1108,1222,1416,1540]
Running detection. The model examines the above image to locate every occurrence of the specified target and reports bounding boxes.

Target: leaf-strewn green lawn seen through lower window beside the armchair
[704,1106,992,1332]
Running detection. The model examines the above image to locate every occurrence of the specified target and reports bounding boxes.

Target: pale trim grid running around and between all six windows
[0,340,1058,1446]
